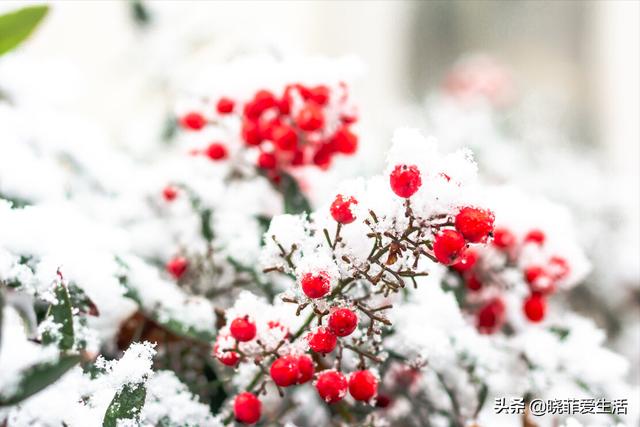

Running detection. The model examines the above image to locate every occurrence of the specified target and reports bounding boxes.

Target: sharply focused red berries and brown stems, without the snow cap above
[238,157,493,422]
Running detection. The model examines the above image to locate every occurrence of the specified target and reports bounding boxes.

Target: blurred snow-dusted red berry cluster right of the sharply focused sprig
[451,227,570,333]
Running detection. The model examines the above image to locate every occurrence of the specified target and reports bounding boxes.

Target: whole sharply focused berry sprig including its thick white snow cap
[214,130,494,423]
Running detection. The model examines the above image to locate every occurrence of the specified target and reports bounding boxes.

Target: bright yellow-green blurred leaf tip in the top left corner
[0,5,49,55]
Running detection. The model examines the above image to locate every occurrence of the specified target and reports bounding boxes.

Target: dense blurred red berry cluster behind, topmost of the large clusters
[179,83,358,176]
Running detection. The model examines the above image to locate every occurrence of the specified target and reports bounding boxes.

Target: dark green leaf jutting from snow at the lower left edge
[0,355,80,406]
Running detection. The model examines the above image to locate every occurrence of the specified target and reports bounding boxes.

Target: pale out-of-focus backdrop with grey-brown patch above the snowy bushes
[0,0,640,382]
